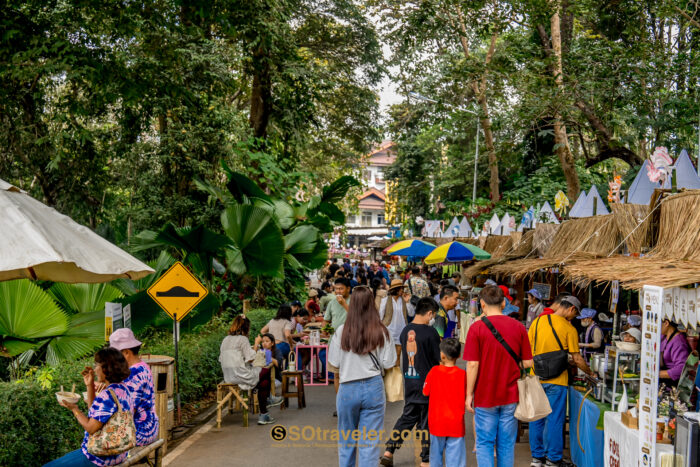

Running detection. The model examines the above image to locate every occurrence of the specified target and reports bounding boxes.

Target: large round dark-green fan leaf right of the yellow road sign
[221,204,284,277]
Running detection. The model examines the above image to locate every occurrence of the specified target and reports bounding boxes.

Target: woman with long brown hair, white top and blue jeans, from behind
[328,287,396,467]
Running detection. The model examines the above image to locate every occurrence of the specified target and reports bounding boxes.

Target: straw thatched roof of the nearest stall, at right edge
[564,190,700,290]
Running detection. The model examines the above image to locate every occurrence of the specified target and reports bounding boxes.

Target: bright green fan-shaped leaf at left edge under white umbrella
[0,280,69,356]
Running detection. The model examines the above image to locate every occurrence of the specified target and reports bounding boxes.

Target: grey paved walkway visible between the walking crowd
[165,372,530,467]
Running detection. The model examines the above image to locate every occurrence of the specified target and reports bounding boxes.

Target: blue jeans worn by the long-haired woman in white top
[335,375,386,467]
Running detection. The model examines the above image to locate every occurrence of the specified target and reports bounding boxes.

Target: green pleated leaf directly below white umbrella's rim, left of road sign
[48,282,124,313]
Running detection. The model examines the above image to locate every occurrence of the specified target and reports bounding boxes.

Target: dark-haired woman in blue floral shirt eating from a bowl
[44,347,132,467]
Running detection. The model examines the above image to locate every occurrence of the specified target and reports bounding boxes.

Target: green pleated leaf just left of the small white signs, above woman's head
[46,311,105,366]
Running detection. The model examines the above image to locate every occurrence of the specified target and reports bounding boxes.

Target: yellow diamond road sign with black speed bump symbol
[148,261,209,321]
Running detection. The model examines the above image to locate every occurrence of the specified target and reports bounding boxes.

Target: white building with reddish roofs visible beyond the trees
[345,141,396,247]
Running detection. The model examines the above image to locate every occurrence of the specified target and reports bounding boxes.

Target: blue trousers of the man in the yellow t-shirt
[530,384,568,462]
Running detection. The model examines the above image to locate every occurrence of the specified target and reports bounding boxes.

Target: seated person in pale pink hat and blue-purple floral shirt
[109,328,158,446]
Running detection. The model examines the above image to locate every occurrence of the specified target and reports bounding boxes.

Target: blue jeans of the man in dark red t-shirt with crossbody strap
[474,404,518,467]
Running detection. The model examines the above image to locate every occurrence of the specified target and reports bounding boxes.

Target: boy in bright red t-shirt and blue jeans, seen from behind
[423,338,467,467]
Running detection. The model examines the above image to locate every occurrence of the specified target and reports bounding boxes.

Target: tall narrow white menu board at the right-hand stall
[639,285,660,467]
